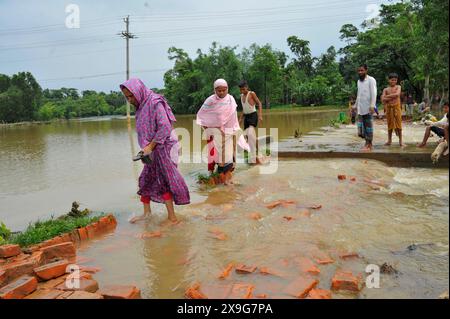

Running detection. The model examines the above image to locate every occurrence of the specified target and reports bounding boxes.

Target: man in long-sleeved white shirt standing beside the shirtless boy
[356,64,377,152]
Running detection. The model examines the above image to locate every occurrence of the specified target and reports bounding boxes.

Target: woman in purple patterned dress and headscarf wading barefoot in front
[120,79,190,223]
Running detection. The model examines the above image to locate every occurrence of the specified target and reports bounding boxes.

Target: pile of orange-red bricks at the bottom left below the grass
[0,215,141,299]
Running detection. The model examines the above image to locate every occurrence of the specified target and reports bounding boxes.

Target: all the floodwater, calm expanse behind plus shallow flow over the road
[0,113,449,298]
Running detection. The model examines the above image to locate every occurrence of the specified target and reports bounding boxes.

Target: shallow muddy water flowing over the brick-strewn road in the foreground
[75,160,449,298]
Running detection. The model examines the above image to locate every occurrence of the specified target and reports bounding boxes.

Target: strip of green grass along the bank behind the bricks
[0,203,104,247]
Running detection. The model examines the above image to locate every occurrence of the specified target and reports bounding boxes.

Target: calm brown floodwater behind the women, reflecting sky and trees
[0,111,336,230]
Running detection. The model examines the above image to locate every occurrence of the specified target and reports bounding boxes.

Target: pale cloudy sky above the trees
[0,0,389,91]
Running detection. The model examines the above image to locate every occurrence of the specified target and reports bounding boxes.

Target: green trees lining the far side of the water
[0,0,449,122]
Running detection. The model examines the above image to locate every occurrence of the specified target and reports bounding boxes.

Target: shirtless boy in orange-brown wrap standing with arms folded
[381,73,404,147]
